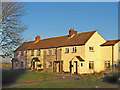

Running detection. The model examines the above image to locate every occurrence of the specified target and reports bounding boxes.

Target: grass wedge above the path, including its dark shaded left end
[2,69,57,85]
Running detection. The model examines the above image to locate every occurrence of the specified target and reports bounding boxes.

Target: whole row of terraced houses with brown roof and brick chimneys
[12,29,120,74]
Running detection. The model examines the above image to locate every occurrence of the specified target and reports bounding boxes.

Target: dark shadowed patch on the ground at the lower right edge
[102,73,120,84]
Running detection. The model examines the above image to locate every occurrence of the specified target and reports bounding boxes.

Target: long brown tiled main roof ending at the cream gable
[27,31,96,49]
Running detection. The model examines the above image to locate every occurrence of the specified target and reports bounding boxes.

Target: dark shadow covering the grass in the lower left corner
[2,69,26,86]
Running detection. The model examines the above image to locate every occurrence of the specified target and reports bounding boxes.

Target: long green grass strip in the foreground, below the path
[10,76,101,88]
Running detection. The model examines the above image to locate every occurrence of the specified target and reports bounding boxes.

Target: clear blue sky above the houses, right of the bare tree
[22,2,118,41]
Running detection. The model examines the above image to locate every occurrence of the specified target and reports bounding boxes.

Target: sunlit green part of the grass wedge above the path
[17,72,57,82]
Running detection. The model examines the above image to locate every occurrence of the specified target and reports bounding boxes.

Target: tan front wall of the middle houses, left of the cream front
[27,48,61,72]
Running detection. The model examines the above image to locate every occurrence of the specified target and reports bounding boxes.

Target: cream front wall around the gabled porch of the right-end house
[61,45,85,72]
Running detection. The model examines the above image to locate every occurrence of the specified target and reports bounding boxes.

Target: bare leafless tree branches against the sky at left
[0,2,26,55]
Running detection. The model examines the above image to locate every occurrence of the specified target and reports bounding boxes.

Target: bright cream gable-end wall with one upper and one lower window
[84,31,106,73]
